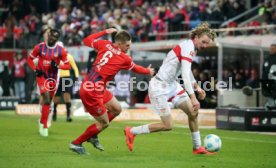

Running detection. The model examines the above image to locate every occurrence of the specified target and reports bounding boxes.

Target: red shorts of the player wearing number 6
[79,86,113,117]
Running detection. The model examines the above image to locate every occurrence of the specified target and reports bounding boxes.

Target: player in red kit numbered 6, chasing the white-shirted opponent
[70,28,154,154]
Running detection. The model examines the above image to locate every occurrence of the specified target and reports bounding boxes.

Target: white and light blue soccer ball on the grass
[204,134,221,152]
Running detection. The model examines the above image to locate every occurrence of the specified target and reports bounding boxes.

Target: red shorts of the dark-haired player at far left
[36,76,57,97]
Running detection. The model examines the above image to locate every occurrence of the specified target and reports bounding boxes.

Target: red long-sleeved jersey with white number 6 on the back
[83,31,150,88]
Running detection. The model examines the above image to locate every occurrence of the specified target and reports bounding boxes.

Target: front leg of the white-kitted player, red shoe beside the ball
[176,93,212,154]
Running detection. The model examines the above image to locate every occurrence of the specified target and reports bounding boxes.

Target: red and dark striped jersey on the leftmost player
[28,42,69,78]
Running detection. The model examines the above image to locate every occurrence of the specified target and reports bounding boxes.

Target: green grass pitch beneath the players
[0,111,276,168]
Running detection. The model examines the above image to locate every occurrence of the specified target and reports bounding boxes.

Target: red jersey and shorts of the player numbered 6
[80,31,151,116]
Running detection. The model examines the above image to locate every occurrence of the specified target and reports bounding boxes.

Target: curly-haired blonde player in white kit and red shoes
[124,23,216,154]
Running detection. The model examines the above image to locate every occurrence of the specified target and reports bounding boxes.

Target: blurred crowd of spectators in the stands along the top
[0,0,276,48]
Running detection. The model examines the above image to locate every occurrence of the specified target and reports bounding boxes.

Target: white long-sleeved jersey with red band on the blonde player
[156,40,195,94]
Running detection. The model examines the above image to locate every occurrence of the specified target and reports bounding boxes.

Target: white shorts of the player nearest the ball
[149,77,189,116]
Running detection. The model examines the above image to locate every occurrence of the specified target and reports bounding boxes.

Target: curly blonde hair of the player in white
[190,22,217,41]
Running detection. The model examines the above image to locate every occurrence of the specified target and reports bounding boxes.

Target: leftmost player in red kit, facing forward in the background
[28,29,70,137]
